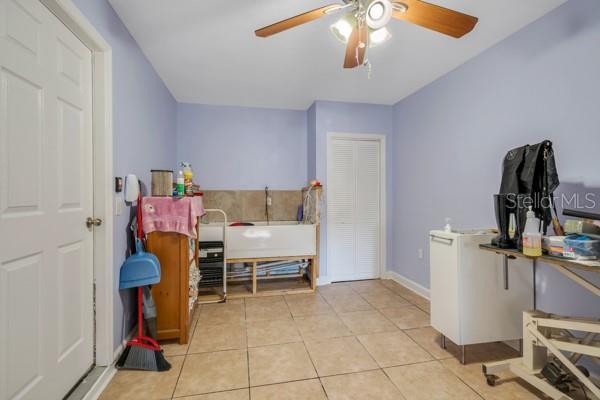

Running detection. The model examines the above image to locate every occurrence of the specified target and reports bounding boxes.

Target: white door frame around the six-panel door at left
[40,0,115,366]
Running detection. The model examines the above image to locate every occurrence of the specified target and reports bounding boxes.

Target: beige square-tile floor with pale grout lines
[101,280,580,400]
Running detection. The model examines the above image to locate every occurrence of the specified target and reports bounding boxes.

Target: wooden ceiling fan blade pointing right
[393,0,478,38]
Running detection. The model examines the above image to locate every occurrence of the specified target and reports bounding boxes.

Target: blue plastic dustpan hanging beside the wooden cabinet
[119,239,160,289]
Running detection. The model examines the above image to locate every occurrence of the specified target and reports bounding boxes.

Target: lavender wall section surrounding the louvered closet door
[309,101,394,277]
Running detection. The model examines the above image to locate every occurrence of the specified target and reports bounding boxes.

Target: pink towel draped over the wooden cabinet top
[142,196,206,239]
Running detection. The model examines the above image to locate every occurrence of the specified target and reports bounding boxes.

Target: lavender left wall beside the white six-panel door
[74,0,177,346]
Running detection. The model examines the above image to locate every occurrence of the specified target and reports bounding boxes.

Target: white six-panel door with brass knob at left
[0,0,94,400]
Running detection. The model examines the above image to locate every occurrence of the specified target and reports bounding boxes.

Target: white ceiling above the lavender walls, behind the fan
[110,0,566,110]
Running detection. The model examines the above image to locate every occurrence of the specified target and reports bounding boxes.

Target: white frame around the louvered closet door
[325,132,387,282]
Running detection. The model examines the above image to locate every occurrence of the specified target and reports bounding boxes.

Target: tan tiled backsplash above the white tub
[203,190,302,222]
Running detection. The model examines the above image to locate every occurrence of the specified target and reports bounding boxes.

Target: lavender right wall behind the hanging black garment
[393,0,600,316]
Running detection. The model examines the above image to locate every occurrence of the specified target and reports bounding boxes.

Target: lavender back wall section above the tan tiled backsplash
[177,104,307,189]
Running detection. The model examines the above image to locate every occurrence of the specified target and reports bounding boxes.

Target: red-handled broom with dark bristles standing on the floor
[115,194,171,371]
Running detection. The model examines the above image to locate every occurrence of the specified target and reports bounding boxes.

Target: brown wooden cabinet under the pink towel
[147,228,198,344]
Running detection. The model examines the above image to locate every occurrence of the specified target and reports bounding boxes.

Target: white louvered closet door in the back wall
[327,137,382,281]
